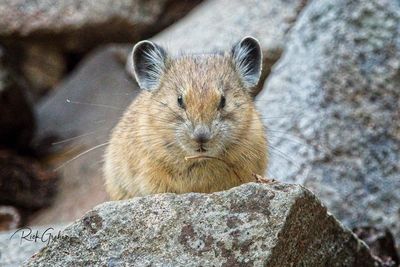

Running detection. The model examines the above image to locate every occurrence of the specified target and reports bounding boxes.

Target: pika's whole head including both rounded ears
[133,38,261,156]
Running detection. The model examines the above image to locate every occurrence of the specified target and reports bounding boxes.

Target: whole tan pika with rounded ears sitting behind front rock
[104,37,267,200]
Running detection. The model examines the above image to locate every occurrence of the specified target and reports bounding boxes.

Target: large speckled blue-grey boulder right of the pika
[258,0,400,247]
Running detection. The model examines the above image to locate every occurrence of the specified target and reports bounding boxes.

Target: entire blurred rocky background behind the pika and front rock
[0,0,400,266]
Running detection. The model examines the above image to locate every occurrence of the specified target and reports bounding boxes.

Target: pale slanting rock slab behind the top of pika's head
[128,0,307,95]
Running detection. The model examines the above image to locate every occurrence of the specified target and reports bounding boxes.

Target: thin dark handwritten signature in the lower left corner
[10,227,62,245]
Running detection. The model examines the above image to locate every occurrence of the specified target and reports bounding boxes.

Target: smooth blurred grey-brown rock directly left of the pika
[30,47,137,225]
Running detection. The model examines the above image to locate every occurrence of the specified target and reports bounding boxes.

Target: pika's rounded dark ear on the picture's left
[132,40,167,91]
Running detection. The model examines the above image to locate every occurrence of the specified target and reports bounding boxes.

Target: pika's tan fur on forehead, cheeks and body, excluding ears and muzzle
[104,54,267,200]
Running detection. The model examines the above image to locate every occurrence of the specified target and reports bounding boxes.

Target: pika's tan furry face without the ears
[159,55,252,156]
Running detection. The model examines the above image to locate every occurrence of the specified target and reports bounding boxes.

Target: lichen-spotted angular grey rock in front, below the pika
[26,183,374,267]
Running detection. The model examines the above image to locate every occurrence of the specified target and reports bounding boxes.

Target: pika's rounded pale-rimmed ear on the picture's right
[232,36,262,90]
